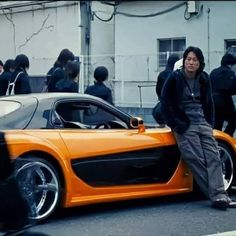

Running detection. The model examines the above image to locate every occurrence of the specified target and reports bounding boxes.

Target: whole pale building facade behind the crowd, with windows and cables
[0,0,236,108]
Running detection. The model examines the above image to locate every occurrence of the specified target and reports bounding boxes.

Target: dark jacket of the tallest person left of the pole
[47,63,65,92]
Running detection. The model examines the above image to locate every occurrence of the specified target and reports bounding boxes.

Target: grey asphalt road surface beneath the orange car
[3,190,236,236]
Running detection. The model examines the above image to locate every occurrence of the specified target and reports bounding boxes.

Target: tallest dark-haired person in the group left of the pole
[46,49,75,92]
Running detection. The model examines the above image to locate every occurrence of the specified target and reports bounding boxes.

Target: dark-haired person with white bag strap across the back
[10,54,31,94]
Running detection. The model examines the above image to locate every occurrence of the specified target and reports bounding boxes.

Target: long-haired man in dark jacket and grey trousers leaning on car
[161,46,236,210]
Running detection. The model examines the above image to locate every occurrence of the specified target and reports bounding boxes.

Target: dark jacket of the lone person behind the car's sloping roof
[85,82,113,104]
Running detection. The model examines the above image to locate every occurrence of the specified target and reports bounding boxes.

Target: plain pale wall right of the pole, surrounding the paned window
[115,1,236,107]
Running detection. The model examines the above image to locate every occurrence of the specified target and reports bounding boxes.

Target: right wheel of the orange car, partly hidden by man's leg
[218,142,234,190]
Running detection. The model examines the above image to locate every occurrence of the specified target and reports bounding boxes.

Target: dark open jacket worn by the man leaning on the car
[161,70,214,133]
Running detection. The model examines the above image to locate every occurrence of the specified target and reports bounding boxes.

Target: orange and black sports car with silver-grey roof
[0,93,236,220]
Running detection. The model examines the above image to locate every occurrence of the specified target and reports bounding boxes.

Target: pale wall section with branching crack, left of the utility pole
[0,1,81,75]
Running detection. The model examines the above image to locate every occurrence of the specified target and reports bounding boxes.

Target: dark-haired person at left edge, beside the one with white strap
[0,59,15,96]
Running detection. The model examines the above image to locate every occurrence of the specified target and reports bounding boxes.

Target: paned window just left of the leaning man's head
[157,38,186,67]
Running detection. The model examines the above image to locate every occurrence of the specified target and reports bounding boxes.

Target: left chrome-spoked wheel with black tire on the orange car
[15,156,61,221]
